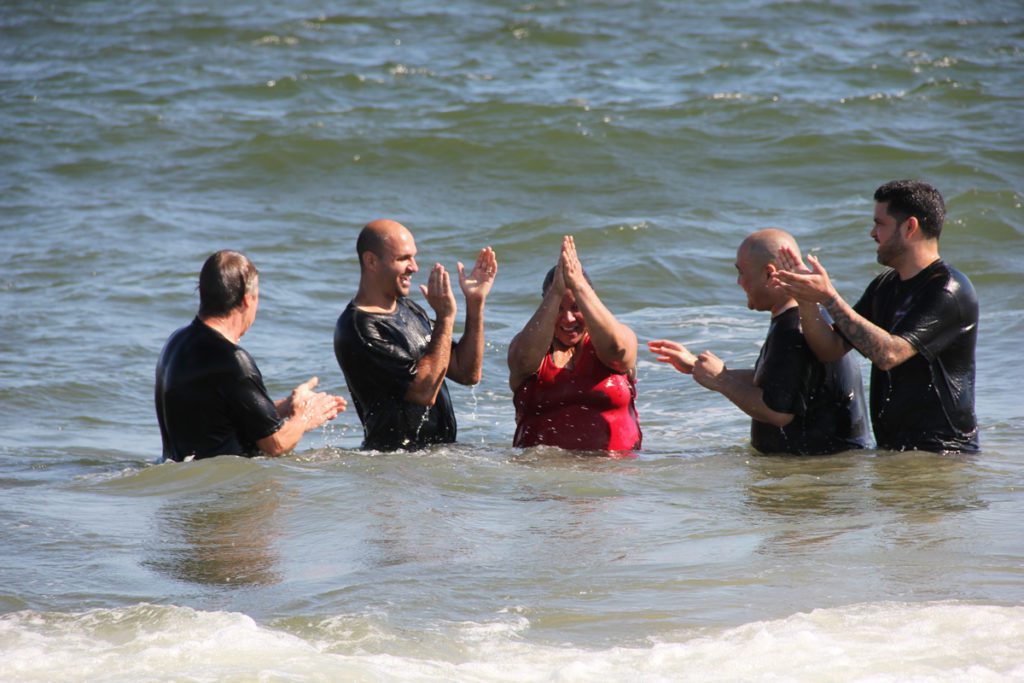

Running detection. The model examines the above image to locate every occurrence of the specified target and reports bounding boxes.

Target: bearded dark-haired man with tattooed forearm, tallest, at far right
[773,180,978,453]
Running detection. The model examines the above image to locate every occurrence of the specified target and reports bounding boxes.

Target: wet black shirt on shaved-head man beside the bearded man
[751,307,867,456]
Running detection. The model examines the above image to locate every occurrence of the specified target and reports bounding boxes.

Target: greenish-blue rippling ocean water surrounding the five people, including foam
[0,0,1024,682]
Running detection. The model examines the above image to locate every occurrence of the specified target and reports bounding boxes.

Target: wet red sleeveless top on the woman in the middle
[512,335,642,451]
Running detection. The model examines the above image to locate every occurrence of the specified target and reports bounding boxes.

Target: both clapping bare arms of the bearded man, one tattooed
[772,247,918,370]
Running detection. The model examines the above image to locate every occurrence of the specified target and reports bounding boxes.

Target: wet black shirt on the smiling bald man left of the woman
[334,297,456,451]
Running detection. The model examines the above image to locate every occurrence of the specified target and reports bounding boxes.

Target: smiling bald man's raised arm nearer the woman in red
[447,247,498,385]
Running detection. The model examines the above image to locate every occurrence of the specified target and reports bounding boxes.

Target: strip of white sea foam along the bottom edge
[0,602,1024,683]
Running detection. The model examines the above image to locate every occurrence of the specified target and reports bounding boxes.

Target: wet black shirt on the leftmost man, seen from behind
[156,317,284,462]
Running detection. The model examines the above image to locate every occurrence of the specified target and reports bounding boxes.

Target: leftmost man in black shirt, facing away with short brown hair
[156,250,346,462]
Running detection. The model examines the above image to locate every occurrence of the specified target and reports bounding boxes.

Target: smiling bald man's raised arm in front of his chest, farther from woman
[403,263,456,405]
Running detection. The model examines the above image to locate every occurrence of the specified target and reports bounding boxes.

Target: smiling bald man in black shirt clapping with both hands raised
[334,219,498,451]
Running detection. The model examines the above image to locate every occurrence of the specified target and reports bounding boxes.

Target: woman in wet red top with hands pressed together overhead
[508,236,641,451]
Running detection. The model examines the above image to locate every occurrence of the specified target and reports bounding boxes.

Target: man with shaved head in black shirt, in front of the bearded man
[648,228,867,456]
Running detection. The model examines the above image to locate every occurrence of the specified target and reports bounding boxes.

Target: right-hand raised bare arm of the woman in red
[560,236,637,375]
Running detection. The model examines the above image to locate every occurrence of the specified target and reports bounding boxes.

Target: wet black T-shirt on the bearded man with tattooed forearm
[854,259,978,453]
